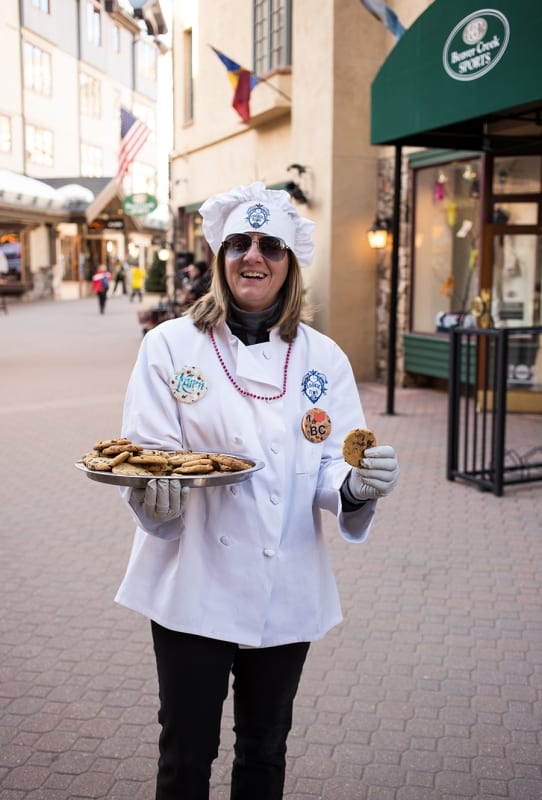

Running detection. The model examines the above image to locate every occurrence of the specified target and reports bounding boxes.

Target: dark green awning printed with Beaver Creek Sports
[371,0,542,152]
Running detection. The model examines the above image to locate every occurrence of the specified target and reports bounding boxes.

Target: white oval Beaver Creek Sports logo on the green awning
[442,8,510,81]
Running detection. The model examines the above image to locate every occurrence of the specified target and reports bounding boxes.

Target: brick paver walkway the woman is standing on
[0,297,542,800]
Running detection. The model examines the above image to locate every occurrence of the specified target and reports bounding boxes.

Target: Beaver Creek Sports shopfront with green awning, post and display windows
[371,0,542,413]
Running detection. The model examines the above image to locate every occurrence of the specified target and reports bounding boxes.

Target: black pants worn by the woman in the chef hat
[152,622,309,800]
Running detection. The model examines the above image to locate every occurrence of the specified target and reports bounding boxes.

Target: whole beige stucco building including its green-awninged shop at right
[171,0,542,406]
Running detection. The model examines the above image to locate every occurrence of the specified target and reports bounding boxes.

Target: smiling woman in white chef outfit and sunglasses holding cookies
[117,183,399,800]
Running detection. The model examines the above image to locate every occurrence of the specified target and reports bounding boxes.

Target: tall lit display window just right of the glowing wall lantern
[412,159,480,333]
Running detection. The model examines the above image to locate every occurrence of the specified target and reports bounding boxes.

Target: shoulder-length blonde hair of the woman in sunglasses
[187,245,312,342]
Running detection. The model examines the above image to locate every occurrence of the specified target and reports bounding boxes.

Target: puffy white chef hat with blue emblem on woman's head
[199,182,315,267]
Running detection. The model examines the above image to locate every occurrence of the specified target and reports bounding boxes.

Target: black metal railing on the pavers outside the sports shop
[447,327,542,497]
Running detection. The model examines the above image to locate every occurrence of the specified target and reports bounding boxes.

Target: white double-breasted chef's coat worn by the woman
[116,317,376,647]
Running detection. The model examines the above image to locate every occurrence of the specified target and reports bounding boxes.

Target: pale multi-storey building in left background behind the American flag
[0,0,168,298]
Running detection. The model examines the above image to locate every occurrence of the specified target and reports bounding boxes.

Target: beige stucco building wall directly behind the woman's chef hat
[171,0,429,379]
